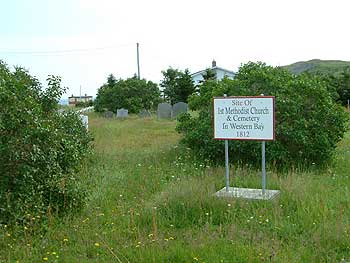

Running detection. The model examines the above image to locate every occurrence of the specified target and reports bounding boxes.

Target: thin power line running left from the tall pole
[0,43,134,55]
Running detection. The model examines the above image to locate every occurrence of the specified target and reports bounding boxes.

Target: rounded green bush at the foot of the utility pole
[95,74,160,113]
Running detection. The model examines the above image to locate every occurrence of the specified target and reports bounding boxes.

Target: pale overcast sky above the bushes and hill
[0,0,350,97]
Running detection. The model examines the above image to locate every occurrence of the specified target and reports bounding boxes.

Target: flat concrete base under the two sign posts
[215,187,280,200]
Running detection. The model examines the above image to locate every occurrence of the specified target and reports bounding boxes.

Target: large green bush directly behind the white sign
[177,63,347,167]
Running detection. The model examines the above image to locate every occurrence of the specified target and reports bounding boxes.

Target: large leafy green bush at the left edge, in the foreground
[0,61,92,222]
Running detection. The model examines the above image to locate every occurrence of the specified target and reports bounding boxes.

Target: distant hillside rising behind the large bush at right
[283,59,350,74]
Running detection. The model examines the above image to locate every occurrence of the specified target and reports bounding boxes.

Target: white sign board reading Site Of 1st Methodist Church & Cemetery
[213,96,275,141]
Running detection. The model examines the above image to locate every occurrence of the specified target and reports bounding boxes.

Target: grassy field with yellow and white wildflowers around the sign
[0,115,350,263]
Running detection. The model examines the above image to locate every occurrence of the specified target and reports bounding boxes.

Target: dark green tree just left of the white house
[160,68,195,104]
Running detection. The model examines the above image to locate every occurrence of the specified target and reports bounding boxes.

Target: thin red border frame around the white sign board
[212,95,276,141]
